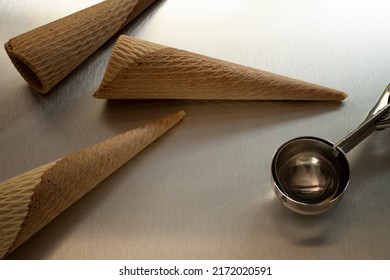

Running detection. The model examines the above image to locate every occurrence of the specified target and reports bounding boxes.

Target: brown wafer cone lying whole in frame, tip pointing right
[94,35,347,100]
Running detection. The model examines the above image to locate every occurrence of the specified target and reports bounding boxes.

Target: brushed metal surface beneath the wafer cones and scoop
[0,0,390,259]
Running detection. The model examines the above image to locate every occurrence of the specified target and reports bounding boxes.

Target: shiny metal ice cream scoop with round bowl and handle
[271,84,390,215]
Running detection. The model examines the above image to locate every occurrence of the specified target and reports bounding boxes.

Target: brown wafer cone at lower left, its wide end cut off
[0,111,185,258]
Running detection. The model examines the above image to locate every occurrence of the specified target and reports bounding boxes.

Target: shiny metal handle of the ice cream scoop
[335,84,390,153]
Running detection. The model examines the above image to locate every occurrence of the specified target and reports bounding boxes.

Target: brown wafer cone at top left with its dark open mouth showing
[5,0,155,93]
